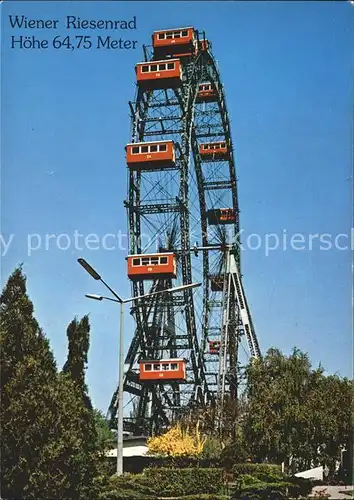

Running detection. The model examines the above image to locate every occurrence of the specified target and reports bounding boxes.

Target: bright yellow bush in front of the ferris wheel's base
[147,424,205,457]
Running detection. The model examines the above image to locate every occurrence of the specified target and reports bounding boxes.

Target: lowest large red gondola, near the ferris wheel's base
[139,359,187,383]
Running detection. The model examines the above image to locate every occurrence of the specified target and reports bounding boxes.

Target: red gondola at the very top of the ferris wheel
[152,27,197,58]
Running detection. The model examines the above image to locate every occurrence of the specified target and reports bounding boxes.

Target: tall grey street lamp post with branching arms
[77,258,201,476]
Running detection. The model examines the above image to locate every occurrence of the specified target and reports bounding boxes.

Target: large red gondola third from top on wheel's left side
[125,141,176,170]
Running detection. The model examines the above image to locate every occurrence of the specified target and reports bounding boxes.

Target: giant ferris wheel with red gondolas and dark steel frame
[109,27,260,434]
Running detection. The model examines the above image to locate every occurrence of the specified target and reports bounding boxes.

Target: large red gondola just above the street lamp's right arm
[127,252,177,280]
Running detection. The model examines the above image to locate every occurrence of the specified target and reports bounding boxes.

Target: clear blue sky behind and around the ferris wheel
[1,2,354,410]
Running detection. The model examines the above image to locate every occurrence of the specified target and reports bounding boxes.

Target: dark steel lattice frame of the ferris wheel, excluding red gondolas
[109,33,261,434]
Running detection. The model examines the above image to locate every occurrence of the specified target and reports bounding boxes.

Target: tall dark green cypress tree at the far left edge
[0,267,57,499]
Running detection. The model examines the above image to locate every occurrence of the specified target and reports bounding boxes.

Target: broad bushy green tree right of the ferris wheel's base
[243,349,352,472]
